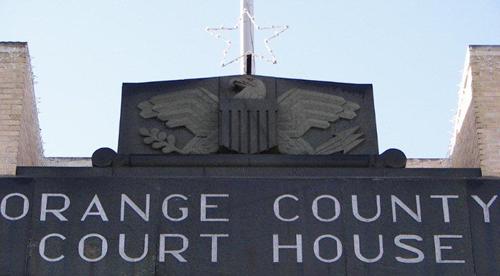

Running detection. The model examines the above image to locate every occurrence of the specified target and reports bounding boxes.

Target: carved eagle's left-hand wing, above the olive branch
[138,88,219,153]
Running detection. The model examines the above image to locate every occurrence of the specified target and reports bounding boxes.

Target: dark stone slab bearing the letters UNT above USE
[342,179,474,275]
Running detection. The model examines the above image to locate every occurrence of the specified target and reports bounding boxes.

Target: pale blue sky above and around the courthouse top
[0,0,500,158]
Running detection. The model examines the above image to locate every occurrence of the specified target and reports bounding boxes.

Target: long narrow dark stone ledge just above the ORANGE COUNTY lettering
[17,166,481,178]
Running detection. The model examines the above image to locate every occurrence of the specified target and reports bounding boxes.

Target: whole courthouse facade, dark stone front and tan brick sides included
[0,42,500,276]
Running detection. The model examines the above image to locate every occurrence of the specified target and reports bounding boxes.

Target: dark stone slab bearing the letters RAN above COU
[28,178,161,275]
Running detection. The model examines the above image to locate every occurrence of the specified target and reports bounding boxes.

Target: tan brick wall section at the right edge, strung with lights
[450,45,500,176]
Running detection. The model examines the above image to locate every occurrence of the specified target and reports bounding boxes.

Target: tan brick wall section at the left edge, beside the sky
[0,42,43,175]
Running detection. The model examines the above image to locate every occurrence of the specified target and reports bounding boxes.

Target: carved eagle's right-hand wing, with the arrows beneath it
[278,88,364,154]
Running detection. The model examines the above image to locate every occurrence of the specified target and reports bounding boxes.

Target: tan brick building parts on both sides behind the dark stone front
[0,42,500,176]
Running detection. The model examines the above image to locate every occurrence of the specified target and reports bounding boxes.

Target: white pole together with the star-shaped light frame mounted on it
[206,0,289,74]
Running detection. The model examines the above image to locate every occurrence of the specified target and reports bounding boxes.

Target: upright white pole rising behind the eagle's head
[240,0,255,75]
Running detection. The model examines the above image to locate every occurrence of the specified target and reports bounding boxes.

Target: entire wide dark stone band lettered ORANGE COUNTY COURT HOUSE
[0,174,500,275]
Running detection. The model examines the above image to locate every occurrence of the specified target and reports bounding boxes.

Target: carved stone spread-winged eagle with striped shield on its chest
[138,76,364,154]
